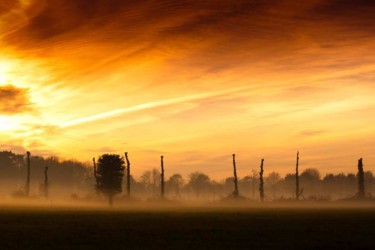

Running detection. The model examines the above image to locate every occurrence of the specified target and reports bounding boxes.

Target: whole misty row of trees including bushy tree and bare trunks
[0,151,375,203]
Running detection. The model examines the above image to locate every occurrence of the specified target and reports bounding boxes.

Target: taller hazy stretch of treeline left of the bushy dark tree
[0,151,92,196]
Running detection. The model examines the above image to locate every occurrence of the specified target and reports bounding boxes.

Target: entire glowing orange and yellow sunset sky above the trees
[0,0,375,178]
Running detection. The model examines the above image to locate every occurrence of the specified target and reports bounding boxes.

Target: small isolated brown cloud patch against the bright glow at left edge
[0,85,31,115]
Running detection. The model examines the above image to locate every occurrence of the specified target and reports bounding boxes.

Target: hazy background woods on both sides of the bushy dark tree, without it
[0,151,375,201]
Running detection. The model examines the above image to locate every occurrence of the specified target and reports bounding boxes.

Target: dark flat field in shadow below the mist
[0,206,375,249]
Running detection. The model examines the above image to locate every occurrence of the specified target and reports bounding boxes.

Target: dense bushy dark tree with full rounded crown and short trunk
[96,154,125,205]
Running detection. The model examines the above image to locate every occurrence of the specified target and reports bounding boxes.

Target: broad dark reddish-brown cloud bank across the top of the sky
[2,0,375,74]
